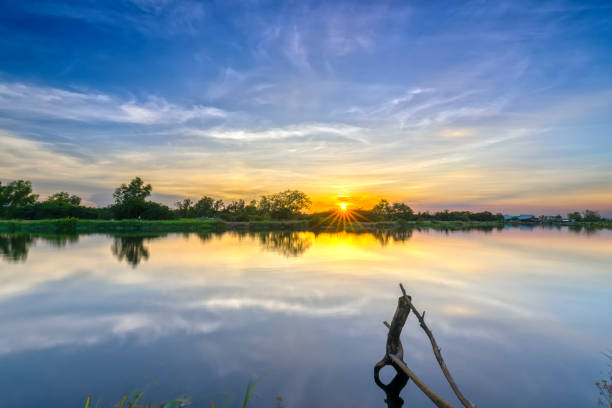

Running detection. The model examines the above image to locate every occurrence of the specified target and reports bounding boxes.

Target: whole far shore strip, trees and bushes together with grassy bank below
[0,177,612,233]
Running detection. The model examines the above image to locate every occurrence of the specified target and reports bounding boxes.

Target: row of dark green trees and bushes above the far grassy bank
[0,177,603,222]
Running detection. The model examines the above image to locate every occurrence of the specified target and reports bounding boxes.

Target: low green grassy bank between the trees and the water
[0,218,612,233]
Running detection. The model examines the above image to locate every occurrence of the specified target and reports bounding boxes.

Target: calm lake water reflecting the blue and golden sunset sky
[0,228,612,408]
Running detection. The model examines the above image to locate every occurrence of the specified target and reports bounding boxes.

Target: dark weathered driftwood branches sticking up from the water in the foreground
[374,283,476,408]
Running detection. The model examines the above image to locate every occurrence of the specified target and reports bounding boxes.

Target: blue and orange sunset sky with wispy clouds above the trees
[0,0,612,216]
